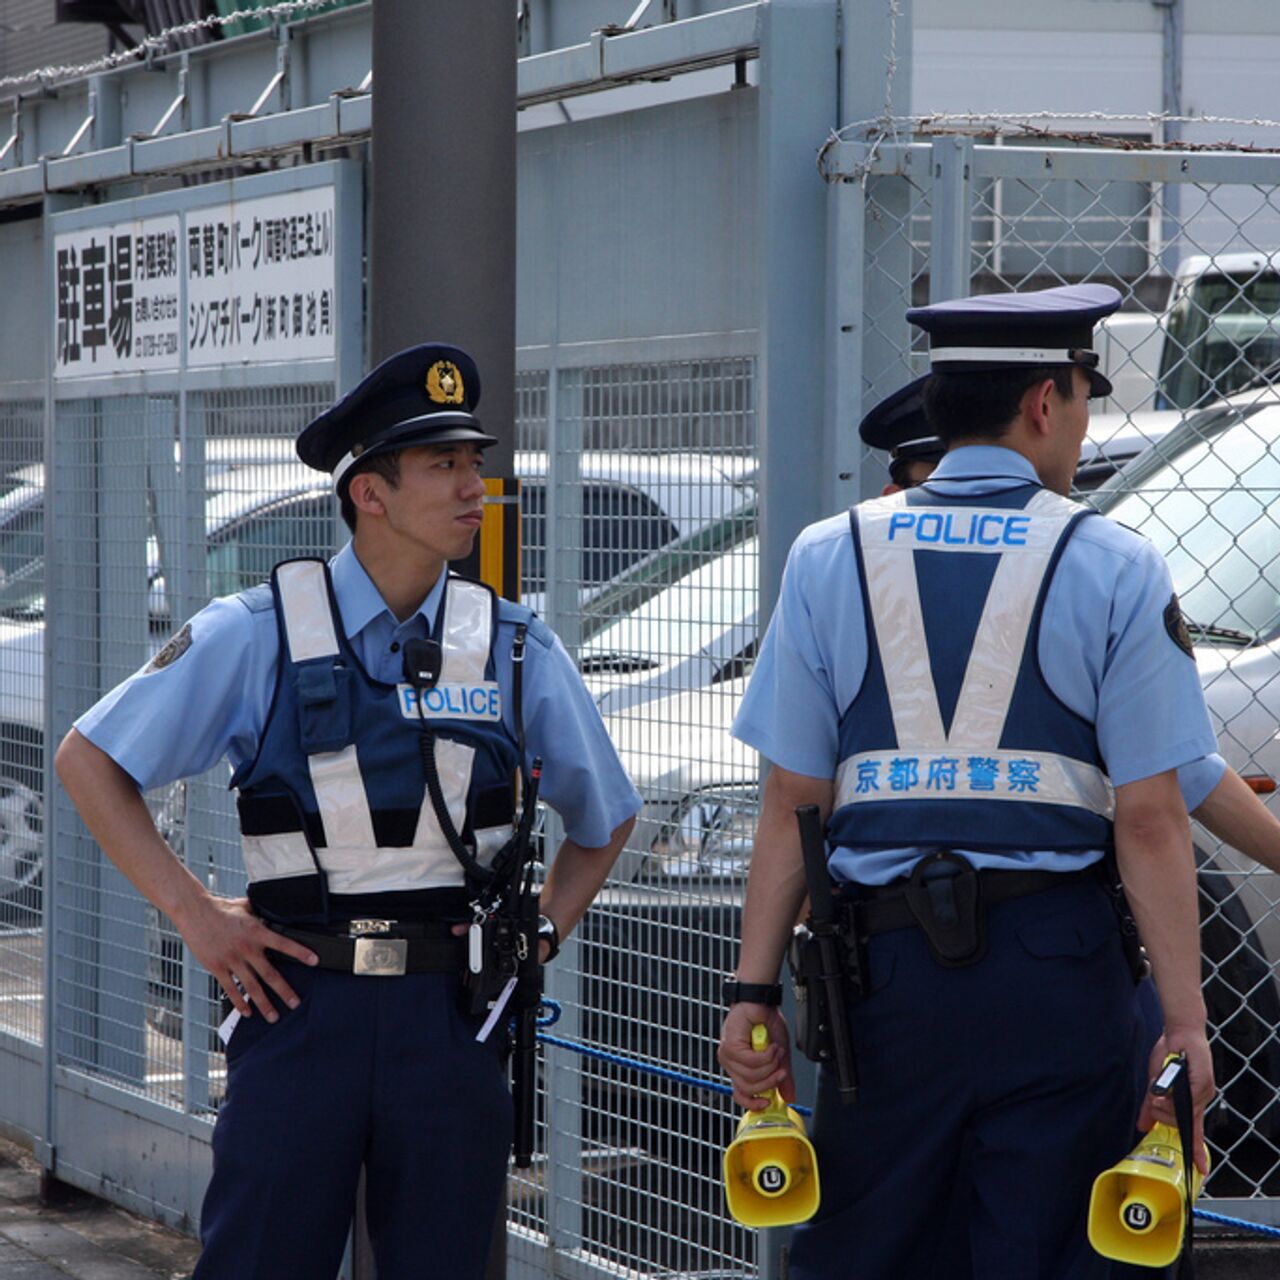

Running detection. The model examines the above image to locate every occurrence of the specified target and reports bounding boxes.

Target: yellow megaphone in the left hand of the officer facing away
[724,1024,819,1226]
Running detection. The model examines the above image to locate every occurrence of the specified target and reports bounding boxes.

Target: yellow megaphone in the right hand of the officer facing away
[1089,1124,1204,1267]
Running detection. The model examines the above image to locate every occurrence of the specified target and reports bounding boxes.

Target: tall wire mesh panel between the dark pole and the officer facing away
[512,357,758,1274]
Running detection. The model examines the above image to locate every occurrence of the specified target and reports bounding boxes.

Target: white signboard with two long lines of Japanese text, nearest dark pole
[184,187,337,367]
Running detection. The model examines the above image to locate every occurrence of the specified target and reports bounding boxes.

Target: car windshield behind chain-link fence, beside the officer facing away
[1106,413,1280,643]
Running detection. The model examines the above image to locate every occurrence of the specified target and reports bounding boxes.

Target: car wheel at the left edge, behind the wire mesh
[0,724,45,924]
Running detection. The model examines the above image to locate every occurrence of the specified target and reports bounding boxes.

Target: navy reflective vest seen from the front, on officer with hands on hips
[232,559,518,923]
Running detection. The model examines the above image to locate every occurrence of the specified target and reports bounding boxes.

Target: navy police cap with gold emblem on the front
[297,342,498,494]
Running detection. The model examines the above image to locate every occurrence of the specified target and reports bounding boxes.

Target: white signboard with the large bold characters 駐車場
[54,214,182,378]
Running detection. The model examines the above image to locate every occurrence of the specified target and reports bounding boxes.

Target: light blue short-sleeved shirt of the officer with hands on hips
[76,543,640,849]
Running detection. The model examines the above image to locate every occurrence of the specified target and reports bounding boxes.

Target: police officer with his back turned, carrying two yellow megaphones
[721,285,1215,1280]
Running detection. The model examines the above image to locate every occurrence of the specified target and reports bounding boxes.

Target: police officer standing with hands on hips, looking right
[56,344,640,1280]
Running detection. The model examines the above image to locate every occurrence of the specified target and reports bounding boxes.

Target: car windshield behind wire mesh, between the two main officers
[582,538,756,664]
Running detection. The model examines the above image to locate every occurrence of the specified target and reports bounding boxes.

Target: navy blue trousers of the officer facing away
[791,878,1146,1280]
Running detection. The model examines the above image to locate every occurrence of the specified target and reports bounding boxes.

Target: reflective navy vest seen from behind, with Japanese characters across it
[828,485,1114,851]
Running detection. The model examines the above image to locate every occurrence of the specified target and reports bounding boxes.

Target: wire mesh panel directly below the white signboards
[55,383,338,1114]
